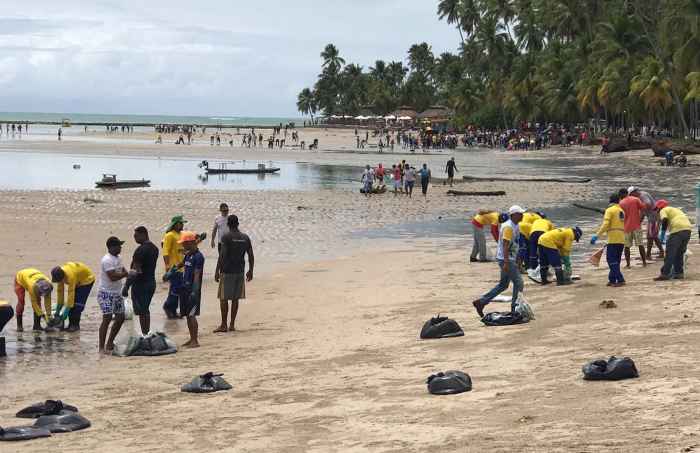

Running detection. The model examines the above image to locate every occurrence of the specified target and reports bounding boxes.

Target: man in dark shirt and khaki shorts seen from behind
[214,215,255,333]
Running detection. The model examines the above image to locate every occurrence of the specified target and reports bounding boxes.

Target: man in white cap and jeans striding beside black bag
[472,206,525,318]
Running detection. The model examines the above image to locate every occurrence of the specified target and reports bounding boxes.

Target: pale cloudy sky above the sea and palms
[0,0,459,117]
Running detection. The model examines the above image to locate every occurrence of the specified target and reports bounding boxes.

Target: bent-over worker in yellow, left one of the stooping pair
[15,268,53,332]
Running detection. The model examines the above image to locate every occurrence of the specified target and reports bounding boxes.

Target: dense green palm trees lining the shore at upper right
[297,0,700,136]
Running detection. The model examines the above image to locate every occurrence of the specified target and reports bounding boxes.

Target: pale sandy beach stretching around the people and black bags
[0,129,700,452]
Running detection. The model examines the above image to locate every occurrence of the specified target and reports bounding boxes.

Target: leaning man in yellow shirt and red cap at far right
[654,200,691,281]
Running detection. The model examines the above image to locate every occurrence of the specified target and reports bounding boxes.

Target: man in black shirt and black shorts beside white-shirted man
[122,226,158,335]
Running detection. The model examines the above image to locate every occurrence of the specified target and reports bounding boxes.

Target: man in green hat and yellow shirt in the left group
[163,215,187,319]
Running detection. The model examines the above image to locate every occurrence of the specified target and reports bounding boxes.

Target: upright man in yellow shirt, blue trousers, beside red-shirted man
[591,194,625,288]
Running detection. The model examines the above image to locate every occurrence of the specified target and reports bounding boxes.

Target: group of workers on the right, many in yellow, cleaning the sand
[470,187,691,317]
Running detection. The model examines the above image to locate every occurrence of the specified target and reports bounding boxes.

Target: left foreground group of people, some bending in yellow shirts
[0,203,255,354]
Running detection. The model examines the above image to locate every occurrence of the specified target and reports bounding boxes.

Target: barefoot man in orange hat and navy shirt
[178,231,204,348]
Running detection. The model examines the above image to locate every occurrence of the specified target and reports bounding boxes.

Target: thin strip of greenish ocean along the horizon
[0,112,304,127]
